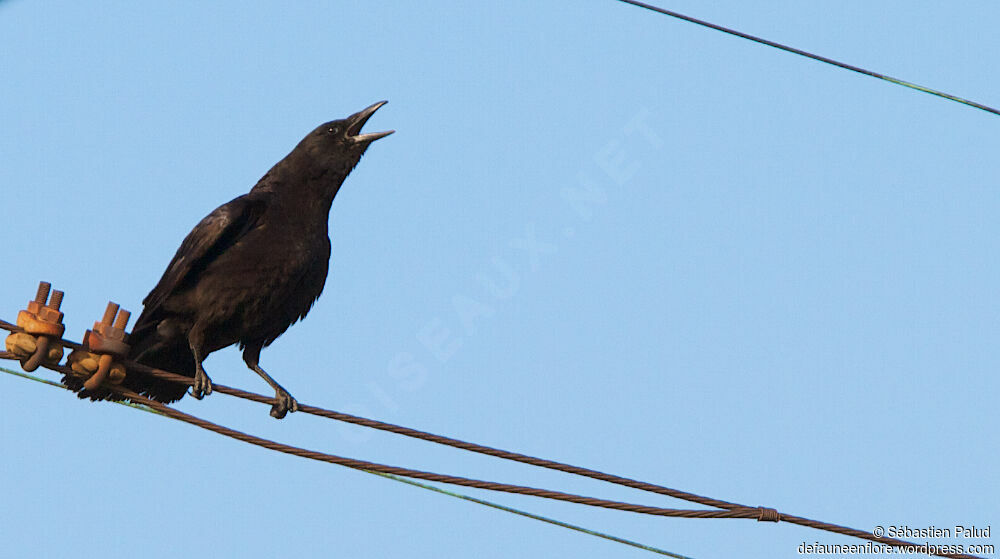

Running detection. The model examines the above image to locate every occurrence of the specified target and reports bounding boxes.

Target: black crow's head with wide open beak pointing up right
[298,101,395,176]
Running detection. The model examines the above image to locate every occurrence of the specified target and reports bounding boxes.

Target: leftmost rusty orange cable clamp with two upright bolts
[7,281,66,372]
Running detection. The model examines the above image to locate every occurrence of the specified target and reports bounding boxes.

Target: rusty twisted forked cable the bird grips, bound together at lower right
[0,319,983,559]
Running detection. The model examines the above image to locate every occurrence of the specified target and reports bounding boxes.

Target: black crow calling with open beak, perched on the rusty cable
[119,101,394,419]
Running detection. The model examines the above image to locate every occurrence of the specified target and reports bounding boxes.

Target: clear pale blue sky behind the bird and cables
[0,0,1000,559]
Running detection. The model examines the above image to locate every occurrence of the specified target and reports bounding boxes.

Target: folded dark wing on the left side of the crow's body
[142,194,265,315]
